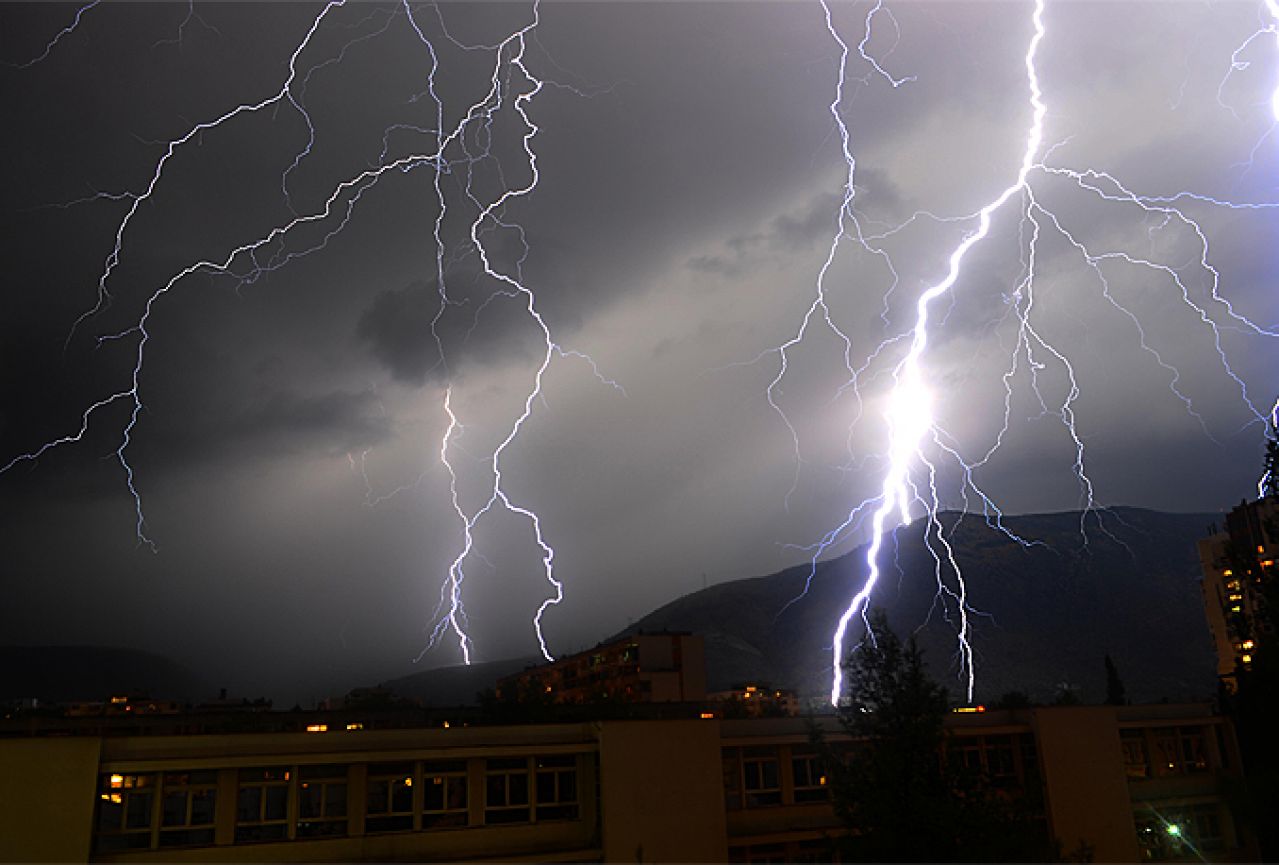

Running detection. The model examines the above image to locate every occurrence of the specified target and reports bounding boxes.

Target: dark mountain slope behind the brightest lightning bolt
[628,508,1215,701]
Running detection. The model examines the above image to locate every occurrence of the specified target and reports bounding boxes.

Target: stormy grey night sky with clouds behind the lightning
[0,0,1279,699]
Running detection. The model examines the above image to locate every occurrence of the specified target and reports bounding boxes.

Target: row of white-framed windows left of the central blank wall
[95,754,581,852]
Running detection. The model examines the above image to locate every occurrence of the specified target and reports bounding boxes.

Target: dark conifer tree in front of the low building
[815,612,1053,862]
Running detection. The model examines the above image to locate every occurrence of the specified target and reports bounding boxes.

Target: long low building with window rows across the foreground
[0,704,1257,862]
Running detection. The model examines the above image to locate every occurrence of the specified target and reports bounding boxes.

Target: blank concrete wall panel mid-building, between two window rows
[600,720,728,862]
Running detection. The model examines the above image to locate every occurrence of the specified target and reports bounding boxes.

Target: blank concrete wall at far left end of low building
[0,738,101,862]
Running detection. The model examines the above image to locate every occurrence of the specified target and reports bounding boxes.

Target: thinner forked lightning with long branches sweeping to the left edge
[0,0,613,663]
